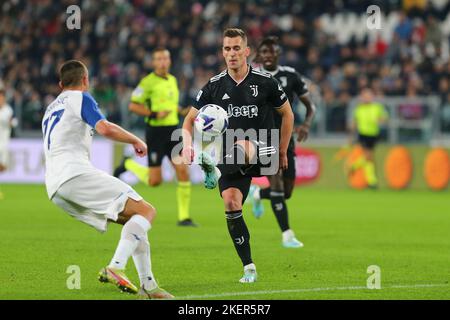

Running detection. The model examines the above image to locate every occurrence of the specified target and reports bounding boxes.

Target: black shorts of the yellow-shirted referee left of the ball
[145,126,181,167]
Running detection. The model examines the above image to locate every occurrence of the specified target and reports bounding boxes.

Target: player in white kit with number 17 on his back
[42,60,173,299]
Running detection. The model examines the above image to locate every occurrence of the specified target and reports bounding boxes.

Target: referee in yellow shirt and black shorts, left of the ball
[114,48,197,227]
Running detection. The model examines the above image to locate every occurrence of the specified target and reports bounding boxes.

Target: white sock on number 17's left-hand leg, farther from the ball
[108,214,151,270]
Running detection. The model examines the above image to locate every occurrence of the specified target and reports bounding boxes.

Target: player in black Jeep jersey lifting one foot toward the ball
[183,28,294,283]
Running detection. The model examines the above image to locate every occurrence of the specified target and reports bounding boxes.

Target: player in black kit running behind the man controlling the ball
[249,37,316,248]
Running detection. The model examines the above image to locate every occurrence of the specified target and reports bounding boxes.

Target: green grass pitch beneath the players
[0,184,450,299]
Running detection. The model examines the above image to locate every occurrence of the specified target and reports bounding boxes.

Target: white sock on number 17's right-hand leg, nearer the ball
[133,235,158,290]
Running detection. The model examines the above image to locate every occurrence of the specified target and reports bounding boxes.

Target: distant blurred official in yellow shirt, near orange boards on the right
[349,88,388,188]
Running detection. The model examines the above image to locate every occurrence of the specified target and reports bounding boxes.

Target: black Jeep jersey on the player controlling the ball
[194,66,287,142]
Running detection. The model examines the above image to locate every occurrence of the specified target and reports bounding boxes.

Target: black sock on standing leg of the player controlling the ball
[225,210,253,266]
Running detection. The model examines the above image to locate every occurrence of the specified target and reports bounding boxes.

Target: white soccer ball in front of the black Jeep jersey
[194,104,228,137]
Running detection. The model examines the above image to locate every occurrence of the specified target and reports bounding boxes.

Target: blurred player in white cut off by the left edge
[0,88,14,199]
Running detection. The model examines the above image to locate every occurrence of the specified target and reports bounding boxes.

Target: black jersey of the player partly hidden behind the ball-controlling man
[261,66,308,128]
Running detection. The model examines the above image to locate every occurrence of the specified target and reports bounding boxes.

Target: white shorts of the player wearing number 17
[52,170,142,232]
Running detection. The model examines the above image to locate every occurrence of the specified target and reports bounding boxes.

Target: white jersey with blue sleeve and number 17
[42,90,105,199]
